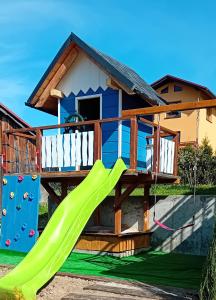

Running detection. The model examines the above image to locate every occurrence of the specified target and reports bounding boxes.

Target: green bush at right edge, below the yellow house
[178,138,216,187]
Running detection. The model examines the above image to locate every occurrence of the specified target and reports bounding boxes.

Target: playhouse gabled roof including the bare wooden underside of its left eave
[26,33,165,114]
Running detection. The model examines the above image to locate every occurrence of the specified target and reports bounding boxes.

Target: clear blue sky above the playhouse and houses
[0,0,216,126]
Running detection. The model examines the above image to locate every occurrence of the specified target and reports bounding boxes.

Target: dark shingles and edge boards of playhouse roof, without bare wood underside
[26,33,166,106]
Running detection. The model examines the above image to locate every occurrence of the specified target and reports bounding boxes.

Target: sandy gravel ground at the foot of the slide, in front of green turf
[0,266,195,300]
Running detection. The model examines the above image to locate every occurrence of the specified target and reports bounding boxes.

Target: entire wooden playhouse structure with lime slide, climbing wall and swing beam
[0,34,216,300]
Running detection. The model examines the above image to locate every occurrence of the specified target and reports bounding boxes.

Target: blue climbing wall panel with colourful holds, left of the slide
[0,175,40,252]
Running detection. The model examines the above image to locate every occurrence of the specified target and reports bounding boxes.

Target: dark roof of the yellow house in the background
[151,74,216,99]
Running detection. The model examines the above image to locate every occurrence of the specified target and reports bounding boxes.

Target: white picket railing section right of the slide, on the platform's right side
[146,138,175,174]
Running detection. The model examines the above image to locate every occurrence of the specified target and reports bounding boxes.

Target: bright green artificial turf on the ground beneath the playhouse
[0,250,205,289]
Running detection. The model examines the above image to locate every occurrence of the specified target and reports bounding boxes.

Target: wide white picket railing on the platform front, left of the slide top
[42,131,94,168]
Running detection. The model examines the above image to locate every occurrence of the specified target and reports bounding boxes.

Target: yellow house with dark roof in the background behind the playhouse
[151,75,216,150]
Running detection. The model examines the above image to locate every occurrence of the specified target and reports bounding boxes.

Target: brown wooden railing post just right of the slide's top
[130,117,138,170]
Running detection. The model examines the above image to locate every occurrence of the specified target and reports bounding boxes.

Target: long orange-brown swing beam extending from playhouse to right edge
[122,99,216,117]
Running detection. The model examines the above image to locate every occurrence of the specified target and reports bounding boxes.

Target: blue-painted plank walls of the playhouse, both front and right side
[61,88,152,170]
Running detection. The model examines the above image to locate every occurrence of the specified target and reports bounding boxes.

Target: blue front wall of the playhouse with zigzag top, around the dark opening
[61,88,118,168]
